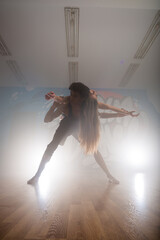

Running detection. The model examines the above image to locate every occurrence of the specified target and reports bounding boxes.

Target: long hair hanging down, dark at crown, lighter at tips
[69,82,100,154]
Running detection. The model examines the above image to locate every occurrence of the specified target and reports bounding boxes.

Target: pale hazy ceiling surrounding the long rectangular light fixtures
[0,0,160,92]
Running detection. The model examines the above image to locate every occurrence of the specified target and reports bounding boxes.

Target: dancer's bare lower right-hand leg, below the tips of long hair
[94,151,119,184]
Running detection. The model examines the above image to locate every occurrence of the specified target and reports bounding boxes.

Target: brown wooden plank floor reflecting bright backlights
[0,165,160,240]
